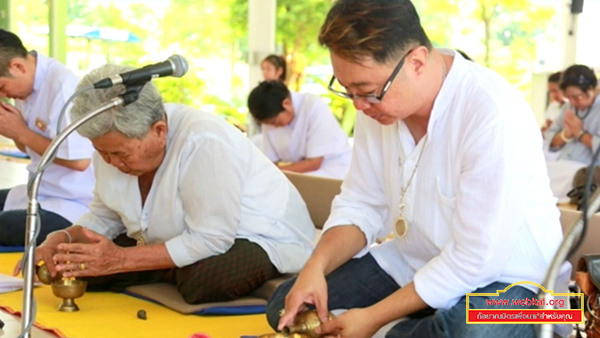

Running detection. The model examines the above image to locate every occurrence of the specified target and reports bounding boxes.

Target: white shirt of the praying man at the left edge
[4,52,94,222]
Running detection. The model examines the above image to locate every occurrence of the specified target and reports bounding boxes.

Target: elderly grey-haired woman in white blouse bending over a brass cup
[15,65,314,304]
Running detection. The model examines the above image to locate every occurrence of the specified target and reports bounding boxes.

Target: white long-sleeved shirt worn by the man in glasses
[325,50,562,309]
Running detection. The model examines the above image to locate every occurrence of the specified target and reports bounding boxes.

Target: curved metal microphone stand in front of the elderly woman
[20,87,141,338]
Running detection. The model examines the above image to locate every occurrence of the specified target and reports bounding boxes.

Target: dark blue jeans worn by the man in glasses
[267,254,536,338]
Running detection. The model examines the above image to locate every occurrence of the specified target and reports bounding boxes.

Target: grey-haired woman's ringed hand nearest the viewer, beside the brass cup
[53,228,126,277]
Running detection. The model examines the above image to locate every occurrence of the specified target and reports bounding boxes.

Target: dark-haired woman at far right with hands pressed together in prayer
[545,65,600,164]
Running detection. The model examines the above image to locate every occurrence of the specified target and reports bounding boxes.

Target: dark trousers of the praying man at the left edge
[0,189,71,246]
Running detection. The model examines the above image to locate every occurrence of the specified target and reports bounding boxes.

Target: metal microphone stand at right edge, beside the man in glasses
[538,189,600,338]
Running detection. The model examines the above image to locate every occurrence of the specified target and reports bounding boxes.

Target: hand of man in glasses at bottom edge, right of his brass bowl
[315,309,380,338]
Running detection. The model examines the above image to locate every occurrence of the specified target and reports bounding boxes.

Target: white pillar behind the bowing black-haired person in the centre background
[248,0,277,136]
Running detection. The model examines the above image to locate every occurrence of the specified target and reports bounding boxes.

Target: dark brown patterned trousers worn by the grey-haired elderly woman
[86,235,281,304]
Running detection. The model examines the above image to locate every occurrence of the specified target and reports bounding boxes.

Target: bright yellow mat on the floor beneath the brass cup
[0,253,272,338]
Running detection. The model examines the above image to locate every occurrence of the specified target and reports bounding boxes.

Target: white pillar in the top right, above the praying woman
[558,0,579,70]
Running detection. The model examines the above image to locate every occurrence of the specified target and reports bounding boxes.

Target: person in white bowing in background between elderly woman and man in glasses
[248,81,352,178]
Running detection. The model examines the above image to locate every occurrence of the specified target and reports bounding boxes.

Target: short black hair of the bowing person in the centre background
[248,80,290,122]
